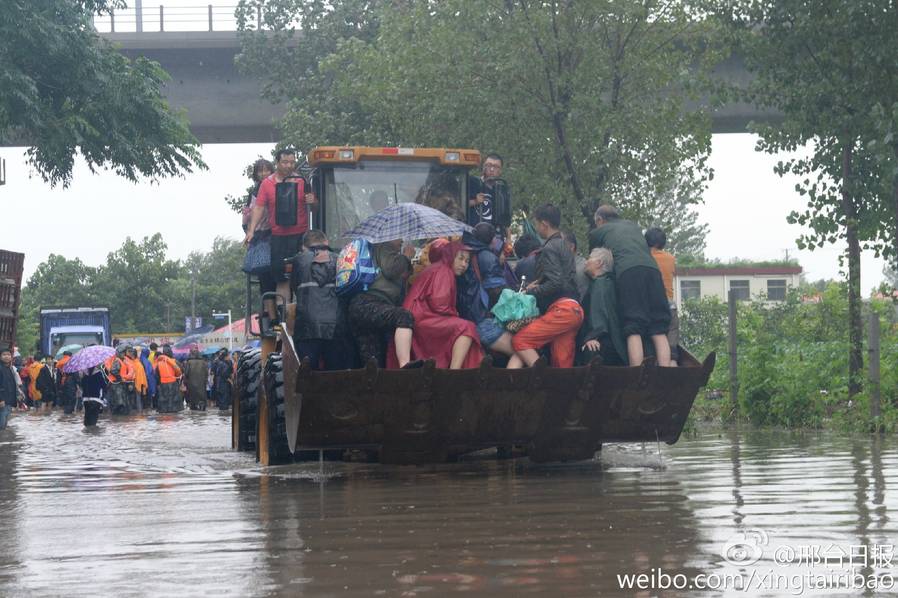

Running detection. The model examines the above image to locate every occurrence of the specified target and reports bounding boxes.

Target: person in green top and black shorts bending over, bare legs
[589,204,670,367]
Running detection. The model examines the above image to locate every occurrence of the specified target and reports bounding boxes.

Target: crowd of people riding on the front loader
[244,150,676,370]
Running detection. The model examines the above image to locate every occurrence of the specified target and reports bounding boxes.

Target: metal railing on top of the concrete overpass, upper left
[94,2,262,33]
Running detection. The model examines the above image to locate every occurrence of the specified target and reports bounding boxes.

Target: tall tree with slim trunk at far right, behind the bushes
[724,0,898,395]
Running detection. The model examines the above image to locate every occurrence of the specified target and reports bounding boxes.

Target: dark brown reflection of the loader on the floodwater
[241,462,695,595]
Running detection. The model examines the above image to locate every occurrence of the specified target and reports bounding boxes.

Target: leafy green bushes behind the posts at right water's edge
[680,282,898,430]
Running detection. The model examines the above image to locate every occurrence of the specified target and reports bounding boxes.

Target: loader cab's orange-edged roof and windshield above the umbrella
[308,146,480,248]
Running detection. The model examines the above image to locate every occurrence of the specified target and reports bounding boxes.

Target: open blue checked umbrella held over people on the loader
[346,203,472,243]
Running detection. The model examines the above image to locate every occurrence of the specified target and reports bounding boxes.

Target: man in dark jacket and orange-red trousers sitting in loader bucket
[508,205,583,368]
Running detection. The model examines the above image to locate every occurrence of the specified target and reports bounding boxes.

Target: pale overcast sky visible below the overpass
[0,134,883,295]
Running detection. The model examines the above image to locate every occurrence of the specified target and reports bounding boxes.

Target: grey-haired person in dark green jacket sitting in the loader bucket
[577,248,629,365]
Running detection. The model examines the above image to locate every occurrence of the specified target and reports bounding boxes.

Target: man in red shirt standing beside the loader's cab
[243,149,317,332]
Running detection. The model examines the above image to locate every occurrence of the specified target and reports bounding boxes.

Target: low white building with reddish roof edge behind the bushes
[674,266,802,305]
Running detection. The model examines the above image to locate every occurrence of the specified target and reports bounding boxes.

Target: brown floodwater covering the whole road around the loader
[0,412,898,597]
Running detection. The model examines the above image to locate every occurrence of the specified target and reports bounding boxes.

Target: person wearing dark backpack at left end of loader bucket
[292,230,355,370]
